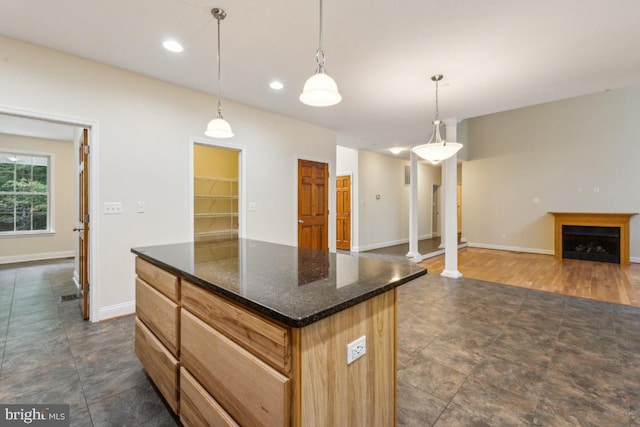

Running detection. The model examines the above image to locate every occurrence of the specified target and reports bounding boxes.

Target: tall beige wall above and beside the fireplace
[462,86,640,261]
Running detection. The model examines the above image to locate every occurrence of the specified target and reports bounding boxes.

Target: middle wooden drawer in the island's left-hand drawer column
[136,277,180,357]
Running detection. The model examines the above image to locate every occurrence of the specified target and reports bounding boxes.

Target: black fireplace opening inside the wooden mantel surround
[562,225,620,264]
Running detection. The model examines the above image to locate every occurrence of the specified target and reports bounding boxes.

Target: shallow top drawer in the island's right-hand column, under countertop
[182,281,291,374]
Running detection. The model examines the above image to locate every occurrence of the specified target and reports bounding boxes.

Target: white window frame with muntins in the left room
[0,147,55,238]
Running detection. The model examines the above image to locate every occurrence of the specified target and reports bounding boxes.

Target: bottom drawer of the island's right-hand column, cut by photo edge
[180,367,239,427]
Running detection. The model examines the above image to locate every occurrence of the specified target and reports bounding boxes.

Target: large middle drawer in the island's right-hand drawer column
[180,309,291,427]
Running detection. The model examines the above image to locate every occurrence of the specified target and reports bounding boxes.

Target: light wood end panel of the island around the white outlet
[294,289,396,427]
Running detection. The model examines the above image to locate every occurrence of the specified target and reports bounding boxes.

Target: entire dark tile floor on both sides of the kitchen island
[0,262,640,426]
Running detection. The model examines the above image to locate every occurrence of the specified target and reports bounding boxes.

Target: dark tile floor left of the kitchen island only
[0,261,177,427]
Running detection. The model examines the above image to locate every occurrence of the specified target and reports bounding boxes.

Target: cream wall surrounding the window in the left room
[0,134,77,264]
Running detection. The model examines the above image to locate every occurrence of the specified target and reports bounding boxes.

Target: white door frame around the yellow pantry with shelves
[188,136,247,238]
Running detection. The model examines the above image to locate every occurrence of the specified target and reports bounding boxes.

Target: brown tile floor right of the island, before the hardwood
[398,274,640,427]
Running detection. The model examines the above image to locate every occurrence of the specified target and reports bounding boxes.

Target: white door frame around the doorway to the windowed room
[0,104,101,322]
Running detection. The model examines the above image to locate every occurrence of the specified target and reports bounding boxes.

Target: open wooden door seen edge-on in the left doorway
[76,129,89,320]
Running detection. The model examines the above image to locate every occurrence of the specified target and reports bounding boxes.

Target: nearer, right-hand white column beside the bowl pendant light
[440,119,462,279]
